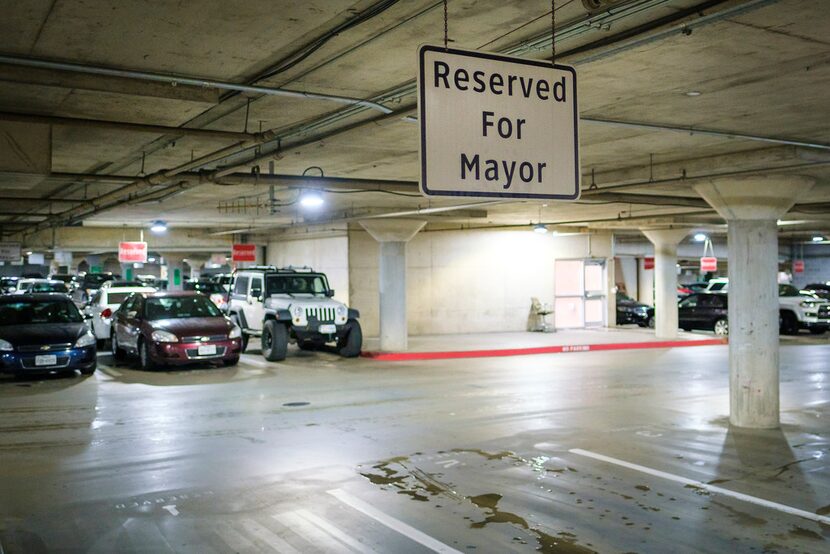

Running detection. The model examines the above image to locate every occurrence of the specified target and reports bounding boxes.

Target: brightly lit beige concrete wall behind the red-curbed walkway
[349,230,613,336]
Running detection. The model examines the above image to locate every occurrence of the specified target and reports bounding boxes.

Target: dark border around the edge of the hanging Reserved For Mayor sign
[417,44,582,200]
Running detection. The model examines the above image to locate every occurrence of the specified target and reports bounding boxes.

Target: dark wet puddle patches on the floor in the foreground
[360,449,595,554]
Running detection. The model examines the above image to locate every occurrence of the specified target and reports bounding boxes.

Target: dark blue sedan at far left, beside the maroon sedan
[0,293,97,375]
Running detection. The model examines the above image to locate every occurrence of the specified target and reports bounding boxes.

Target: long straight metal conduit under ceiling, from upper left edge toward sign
[0,55,392,113]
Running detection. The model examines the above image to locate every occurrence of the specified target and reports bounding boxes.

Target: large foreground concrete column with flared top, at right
[695,175,814,429]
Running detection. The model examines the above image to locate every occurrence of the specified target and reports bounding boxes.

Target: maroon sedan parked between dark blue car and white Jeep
[110,292,242,370]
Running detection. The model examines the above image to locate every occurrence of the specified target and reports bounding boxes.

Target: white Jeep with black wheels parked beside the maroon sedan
[227,266,363,362]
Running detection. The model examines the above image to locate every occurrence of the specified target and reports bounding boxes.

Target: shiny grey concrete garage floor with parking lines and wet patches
[0,342,830,553]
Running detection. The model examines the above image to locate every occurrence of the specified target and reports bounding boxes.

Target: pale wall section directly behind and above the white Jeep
[265,234,352,309]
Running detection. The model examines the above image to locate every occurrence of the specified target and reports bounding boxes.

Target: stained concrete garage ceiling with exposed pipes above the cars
[0,0,830,248]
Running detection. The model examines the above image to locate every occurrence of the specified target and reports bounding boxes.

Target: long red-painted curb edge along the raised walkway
[360,339,727,362]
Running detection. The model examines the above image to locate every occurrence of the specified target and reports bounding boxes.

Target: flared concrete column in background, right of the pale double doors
[642,228,691,339]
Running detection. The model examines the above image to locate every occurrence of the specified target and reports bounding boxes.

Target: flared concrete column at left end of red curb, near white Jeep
[360,219,426,351]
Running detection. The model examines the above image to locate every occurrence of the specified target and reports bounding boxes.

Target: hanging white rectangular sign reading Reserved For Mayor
[418,46,580,200]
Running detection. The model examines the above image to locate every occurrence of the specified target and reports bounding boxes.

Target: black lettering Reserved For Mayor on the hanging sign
[433,61,567,190]
